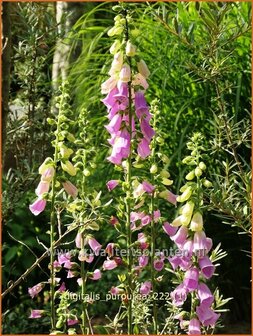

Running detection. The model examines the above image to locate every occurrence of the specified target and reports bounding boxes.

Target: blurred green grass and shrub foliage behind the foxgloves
[2,1,251,334]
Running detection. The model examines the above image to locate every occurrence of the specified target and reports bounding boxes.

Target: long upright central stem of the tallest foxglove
[125,11,133,335]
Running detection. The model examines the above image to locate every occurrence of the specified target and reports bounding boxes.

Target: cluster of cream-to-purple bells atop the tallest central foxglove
[101,30,155,165]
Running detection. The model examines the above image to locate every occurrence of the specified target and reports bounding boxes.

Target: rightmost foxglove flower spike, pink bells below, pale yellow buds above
[167,136,220,335]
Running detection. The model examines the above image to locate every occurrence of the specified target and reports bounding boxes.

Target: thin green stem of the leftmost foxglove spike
[50,93,63,331]
